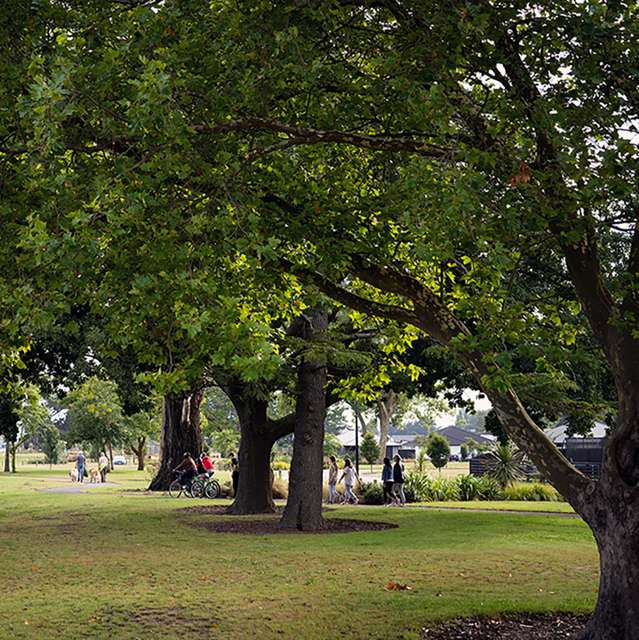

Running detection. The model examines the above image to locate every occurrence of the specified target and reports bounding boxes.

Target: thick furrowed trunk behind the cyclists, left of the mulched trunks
[149,391,203,491]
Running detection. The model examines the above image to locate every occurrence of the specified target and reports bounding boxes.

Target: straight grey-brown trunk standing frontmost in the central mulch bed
[280,311,328,531]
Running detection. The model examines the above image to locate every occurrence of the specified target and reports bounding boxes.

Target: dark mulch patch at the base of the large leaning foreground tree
[422,613,588,640]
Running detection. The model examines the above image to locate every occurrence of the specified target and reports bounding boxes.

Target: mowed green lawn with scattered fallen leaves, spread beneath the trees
[0,467,597,640]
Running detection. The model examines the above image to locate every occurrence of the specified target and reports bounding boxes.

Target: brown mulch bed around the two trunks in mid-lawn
[183,507,397,535]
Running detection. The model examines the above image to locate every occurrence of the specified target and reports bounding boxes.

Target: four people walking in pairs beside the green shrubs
[328,455,406,507]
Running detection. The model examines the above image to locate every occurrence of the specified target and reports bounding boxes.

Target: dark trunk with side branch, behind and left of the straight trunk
[228,397,275,515]
